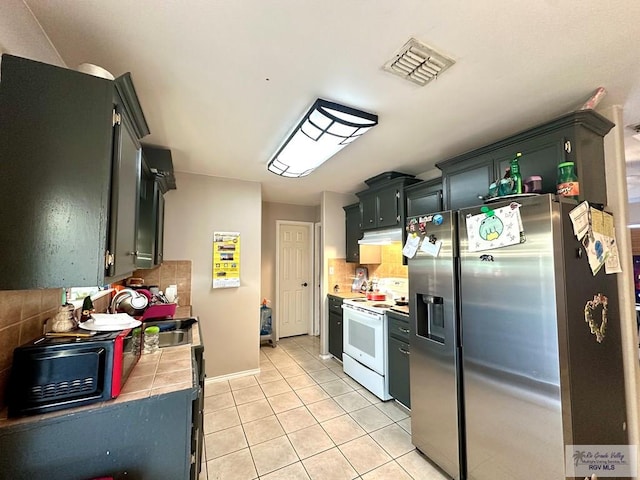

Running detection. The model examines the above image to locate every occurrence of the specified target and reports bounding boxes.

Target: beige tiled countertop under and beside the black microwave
[0,322,201,428]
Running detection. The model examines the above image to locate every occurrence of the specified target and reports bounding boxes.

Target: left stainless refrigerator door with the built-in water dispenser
[409,212,461,479]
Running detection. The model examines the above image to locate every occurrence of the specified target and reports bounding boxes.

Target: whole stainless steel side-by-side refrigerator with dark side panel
[408,195,628,480]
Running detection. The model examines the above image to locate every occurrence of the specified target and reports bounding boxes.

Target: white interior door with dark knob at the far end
[276,222,313,338]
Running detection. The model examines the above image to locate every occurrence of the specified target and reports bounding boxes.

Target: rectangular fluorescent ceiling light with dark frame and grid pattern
[267,98,378,178]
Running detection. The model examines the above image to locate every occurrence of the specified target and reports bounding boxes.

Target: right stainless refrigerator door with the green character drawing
[458,195,564,480]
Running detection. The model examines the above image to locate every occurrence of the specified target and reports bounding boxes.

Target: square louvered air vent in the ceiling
[383,38,455,86]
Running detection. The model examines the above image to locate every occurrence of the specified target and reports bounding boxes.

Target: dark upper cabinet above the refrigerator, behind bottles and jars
[437,110,614,210]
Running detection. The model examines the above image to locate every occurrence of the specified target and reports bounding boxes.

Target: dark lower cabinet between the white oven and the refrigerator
[387,311,411,408]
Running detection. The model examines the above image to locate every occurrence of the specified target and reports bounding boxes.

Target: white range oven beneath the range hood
[342,298,392,400]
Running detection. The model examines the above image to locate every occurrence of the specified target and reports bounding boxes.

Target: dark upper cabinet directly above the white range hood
[356,172,420,230]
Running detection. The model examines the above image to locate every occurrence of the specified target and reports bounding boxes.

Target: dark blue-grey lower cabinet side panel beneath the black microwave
[0,389,197,480]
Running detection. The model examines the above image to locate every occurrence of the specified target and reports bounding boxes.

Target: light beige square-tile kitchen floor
[200,336,447,480]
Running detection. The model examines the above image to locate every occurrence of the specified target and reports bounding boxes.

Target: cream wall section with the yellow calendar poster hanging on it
[164,172,262,377]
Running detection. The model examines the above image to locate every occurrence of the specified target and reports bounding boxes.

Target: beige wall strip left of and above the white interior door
[260,202,320,318]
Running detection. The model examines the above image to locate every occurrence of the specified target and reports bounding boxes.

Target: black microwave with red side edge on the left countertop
[6,328,143,417]
